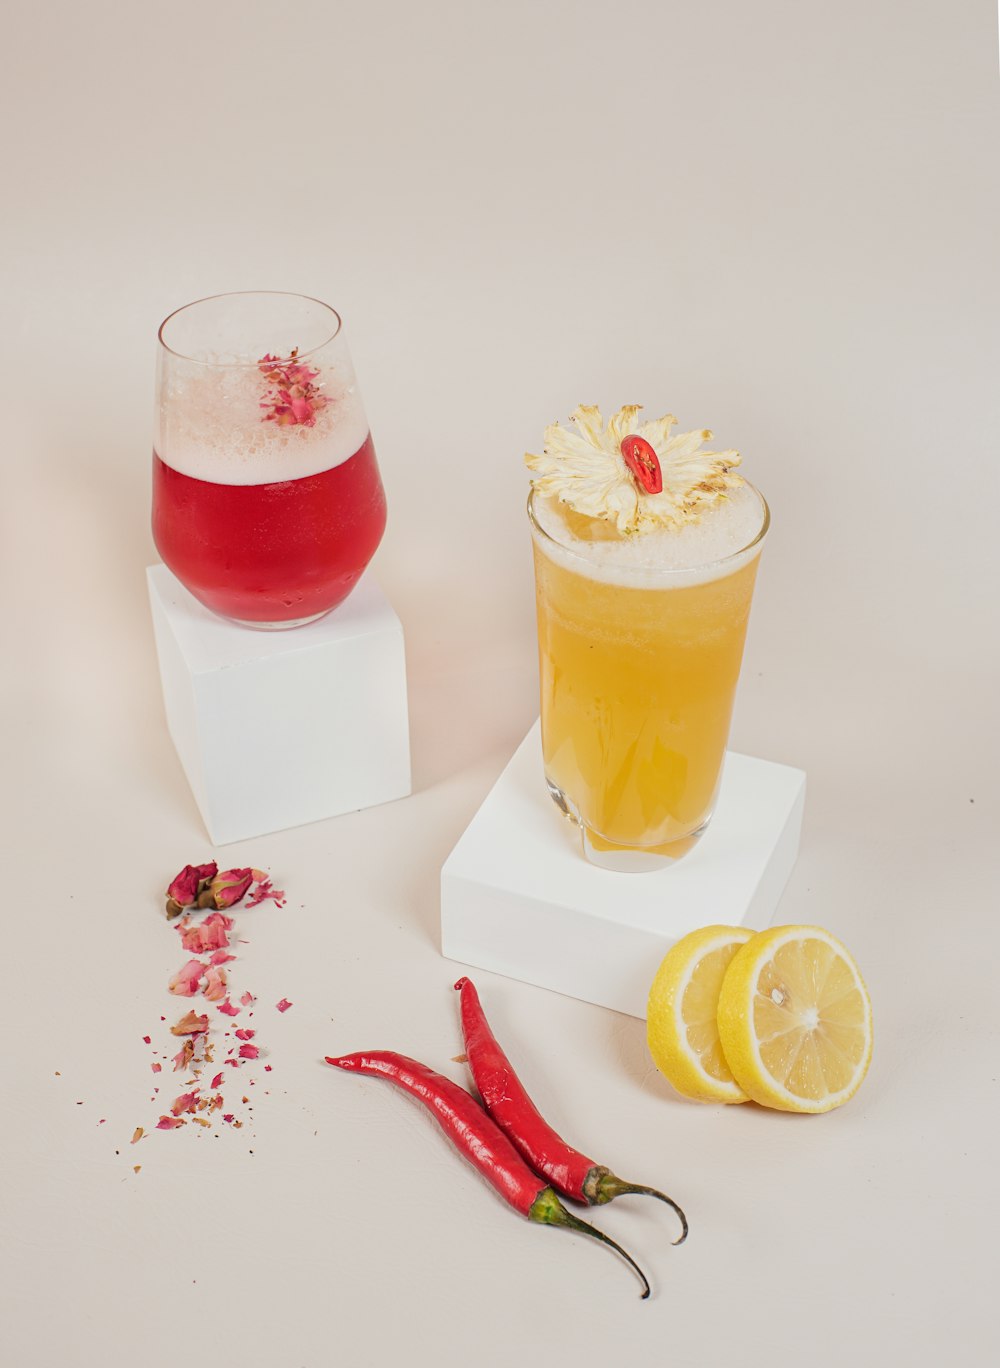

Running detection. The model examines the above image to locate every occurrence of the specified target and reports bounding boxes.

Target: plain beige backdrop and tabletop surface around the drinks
[0,0,1000,1368]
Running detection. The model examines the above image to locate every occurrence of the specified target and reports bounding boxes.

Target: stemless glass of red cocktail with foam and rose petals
[153,293,386,629]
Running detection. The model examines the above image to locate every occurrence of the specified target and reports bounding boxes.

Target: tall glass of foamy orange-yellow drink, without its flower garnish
[529,484,767,869]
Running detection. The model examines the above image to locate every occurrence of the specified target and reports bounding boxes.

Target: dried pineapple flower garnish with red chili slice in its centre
[524,404,743,535]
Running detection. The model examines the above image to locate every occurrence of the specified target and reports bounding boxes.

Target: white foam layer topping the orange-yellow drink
[532,484,765,588]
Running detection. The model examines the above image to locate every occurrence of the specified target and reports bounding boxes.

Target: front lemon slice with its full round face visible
[718,926,871,1112]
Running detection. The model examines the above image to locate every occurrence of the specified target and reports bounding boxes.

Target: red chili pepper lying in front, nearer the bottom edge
[326,1049,650,1298]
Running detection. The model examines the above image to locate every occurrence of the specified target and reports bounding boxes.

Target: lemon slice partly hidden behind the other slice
[646,926,754,1103]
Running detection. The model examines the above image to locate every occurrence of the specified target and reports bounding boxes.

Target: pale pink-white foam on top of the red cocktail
[153,363,368,484]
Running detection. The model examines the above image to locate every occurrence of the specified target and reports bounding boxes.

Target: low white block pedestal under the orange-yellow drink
[440,724,806,1016]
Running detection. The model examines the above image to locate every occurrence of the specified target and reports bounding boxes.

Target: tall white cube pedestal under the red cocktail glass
[146,565,410,845]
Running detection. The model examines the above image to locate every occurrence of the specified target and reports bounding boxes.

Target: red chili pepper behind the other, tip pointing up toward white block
[456,978,688,1245]
